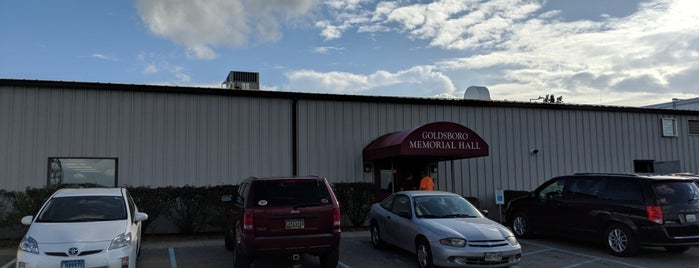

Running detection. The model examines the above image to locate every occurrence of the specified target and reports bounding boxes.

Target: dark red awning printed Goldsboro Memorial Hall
[362,122,489,161]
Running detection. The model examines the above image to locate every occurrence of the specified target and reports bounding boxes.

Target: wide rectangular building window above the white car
[48,157,117,187]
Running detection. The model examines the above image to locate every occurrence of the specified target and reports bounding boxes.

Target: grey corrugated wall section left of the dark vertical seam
[0,86,292,190]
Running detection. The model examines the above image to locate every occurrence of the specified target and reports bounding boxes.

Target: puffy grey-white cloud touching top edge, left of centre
[136,0,316,59]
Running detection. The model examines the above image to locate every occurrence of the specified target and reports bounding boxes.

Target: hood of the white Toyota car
[27,220,127,244]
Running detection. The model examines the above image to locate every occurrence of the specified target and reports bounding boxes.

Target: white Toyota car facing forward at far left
[16,188,148,268]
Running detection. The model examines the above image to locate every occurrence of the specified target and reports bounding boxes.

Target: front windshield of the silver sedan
[414,196,483,218]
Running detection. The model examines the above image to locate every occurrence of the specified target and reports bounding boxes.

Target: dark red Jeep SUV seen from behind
[226,177,340,268]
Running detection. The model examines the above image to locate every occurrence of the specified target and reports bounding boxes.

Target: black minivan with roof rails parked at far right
[506,174,699,256]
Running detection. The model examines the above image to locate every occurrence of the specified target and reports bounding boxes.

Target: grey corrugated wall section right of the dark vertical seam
[299,100,699,209]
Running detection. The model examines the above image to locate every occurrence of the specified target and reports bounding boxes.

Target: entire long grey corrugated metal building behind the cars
[0,79,699,213]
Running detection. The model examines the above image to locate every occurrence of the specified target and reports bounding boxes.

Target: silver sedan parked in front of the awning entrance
[370,191,522,267]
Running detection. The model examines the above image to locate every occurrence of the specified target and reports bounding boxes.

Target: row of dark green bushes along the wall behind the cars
[0,183,529,237]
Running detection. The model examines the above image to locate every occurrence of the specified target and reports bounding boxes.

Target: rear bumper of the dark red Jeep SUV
[241,233,340,255]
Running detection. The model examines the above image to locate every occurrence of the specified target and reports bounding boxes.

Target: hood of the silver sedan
[424,218,513,240]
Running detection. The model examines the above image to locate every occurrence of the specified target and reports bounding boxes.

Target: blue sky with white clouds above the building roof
[0,0,699,106]
